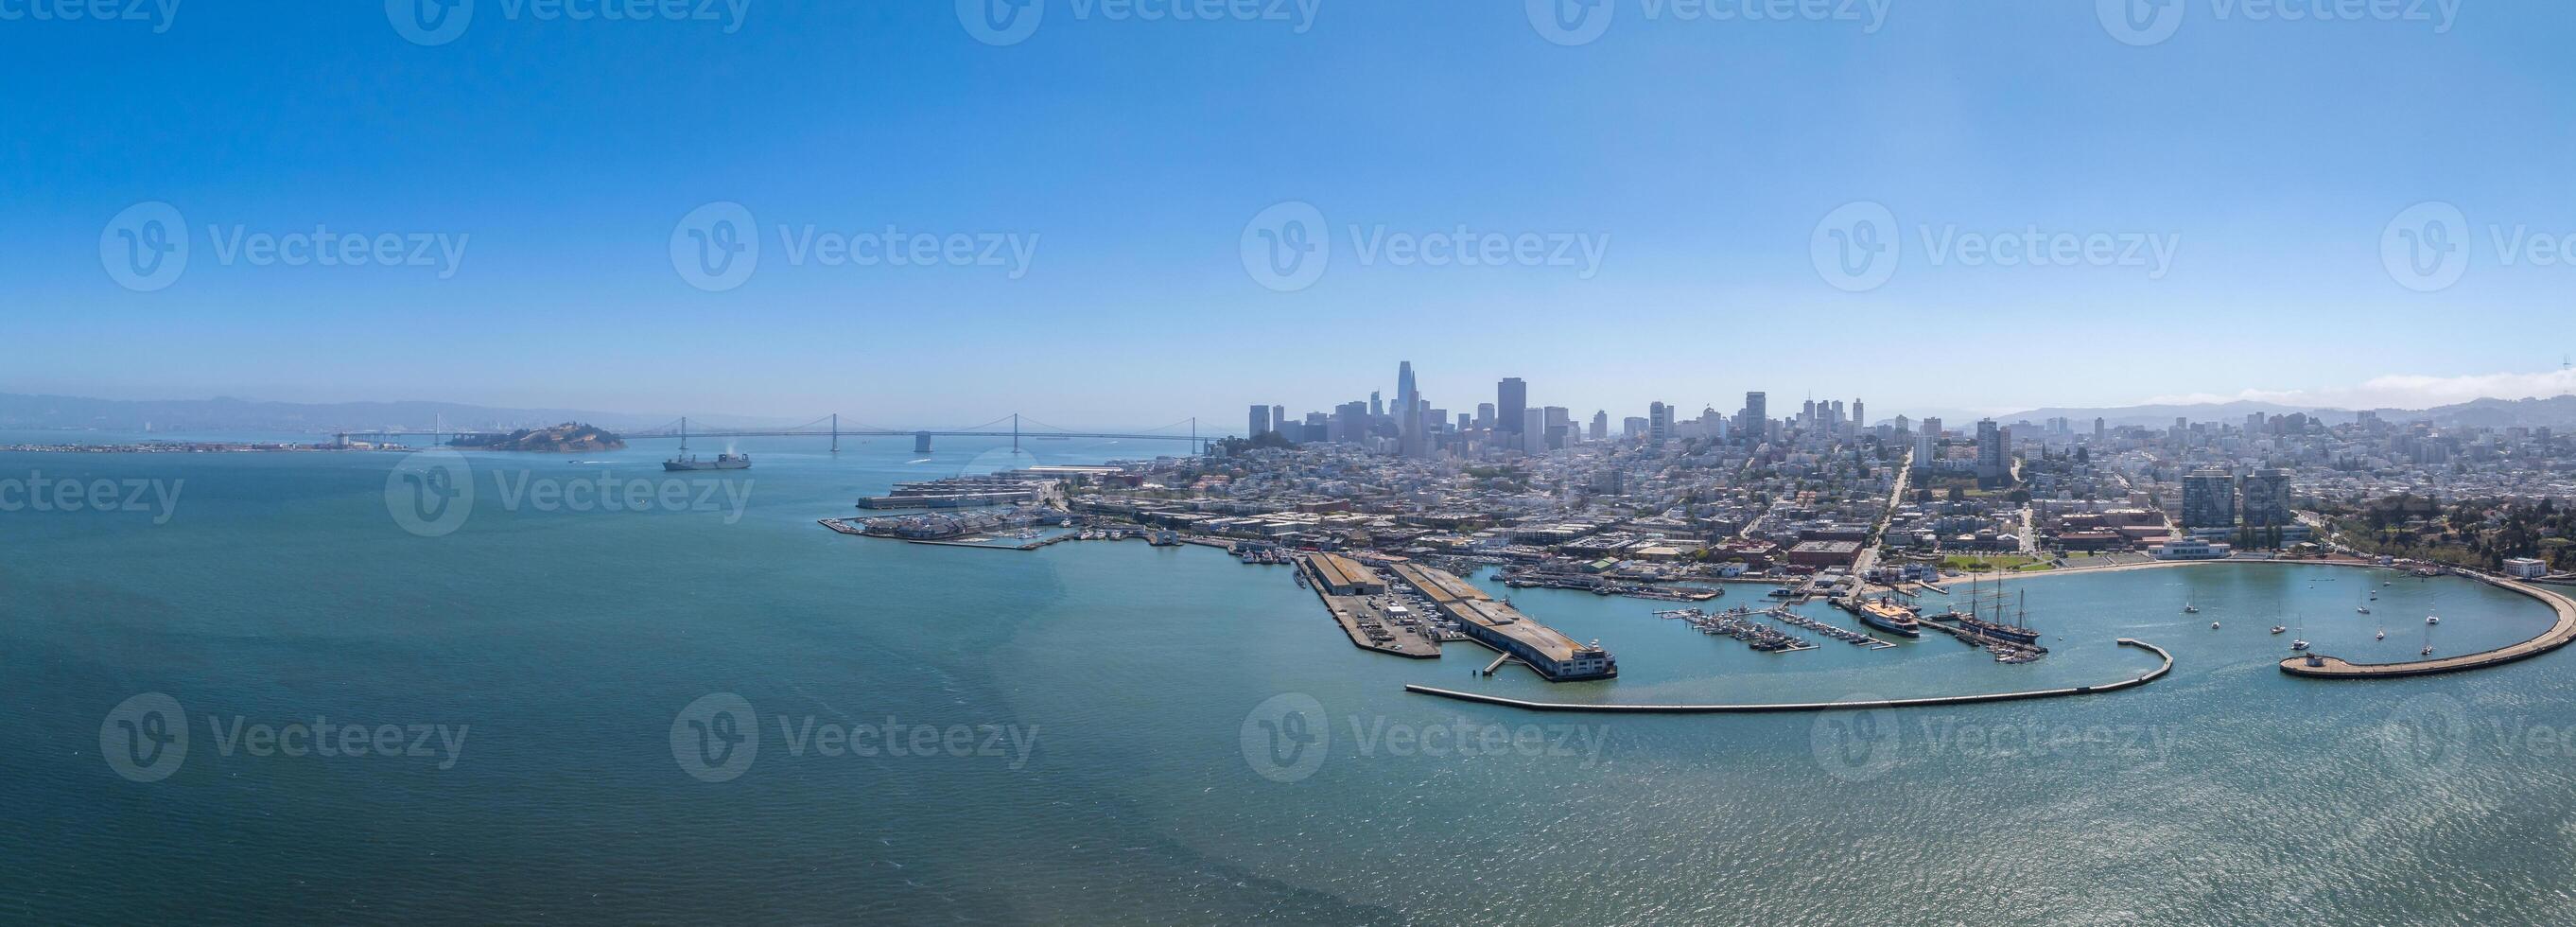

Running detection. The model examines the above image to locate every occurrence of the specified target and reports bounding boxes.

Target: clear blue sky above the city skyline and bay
[0,0,2576,425]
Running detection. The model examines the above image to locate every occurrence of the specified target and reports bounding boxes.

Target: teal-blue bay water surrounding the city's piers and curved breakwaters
[0,435,2576,924]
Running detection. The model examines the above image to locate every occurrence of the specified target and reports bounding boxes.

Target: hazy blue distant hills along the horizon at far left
[0,394,780,435]
